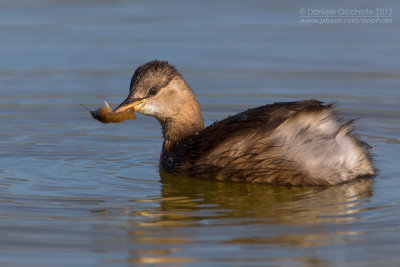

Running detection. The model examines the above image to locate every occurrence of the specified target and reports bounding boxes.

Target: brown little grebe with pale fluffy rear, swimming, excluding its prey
[115,60,375,185]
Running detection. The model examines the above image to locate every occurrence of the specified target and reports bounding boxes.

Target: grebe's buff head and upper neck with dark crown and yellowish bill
[115,60,204,144]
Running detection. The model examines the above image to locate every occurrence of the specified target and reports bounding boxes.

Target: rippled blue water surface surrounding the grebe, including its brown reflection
[0,0,400,266]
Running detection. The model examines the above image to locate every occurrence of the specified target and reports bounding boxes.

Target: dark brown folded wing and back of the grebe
[173,100,331,181]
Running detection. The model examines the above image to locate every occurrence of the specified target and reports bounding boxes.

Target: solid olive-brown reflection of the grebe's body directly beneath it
[159,170,373,224]
